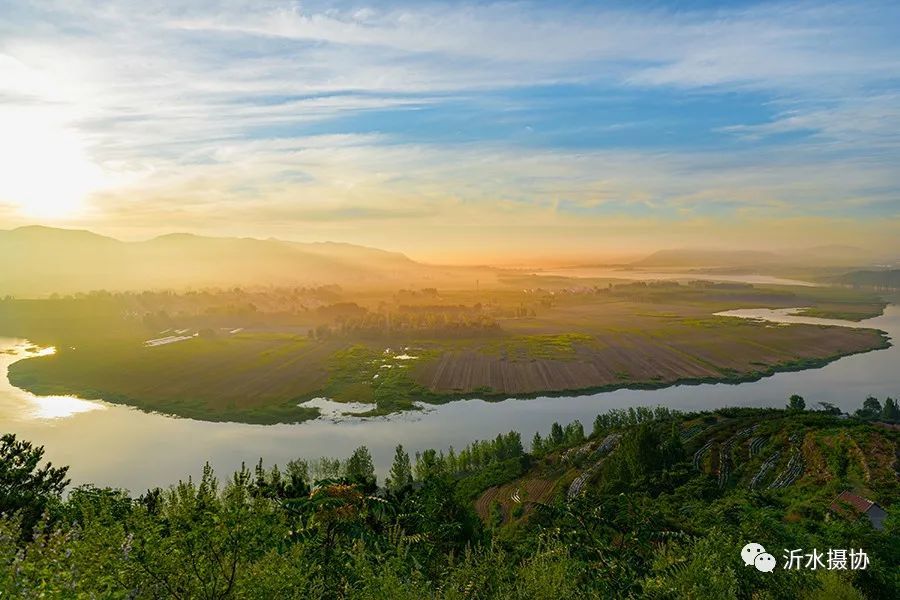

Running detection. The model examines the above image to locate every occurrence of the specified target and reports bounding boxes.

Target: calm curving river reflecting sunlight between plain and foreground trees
[0,304,900,493]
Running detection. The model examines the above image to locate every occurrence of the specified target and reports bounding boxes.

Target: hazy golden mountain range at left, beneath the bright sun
[0,226,436,296]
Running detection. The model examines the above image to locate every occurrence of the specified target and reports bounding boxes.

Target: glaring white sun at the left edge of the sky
[0,113,103,220]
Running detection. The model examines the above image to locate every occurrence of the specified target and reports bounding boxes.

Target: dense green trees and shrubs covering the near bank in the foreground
[0,402,900,599]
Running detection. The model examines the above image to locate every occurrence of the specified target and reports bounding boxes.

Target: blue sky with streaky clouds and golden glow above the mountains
[0,0,900,263]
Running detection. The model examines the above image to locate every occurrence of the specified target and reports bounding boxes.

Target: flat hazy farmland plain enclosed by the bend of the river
[0,277,887,423]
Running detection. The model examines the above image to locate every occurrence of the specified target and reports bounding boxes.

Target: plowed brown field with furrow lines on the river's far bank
[417,323,881,395]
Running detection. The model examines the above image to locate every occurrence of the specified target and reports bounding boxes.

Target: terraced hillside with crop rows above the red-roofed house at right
[475,409,900,526]
